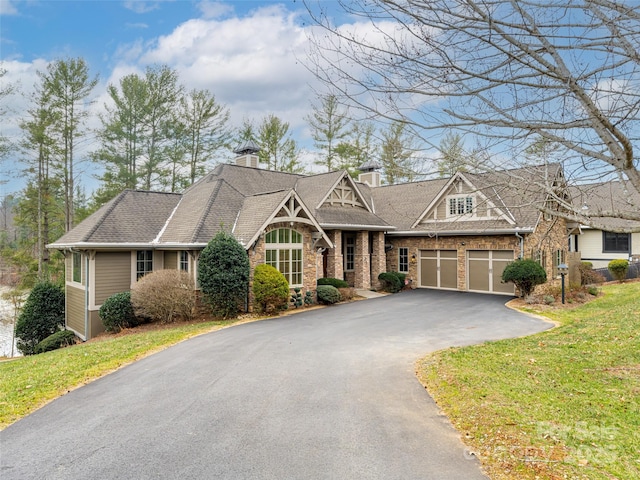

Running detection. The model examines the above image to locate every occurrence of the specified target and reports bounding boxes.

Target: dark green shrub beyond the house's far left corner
[16,282,64,355]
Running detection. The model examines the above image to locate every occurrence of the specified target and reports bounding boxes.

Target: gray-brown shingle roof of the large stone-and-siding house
[51,164,568,248]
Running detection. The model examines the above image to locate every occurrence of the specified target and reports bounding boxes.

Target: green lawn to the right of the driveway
[418,283,640,480]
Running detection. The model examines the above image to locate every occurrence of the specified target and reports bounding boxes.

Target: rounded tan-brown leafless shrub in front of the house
[131,270,196,323]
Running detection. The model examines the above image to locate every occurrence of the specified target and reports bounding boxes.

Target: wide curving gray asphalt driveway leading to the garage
[0,290,550,480]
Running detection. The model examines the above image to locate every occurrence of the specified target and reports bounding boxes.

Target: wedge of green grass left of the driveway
[0,321,240,430]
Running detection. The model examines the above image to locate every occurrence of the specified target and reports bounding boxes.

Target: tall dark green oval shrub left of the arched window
[198,231,249,318]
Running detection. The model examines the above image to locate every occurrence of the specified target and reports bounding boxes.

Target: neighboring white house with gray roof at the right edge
[570,181,640,268]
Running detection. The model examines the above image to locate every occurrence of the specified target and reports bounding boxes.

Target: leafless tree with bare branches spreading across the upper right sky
[307,0,640,230]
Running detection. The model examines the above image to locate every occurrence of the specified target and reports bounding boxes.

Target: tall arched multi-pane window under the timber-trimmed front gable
[264,228,302,287]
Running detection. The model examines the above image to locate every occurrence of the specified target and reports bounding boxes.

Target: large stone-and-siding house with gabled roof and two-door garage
[48,148,567,339]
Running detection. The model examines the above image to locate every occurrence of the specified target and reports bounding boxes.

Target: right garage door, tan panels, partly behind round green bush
[467,250,515,295]
